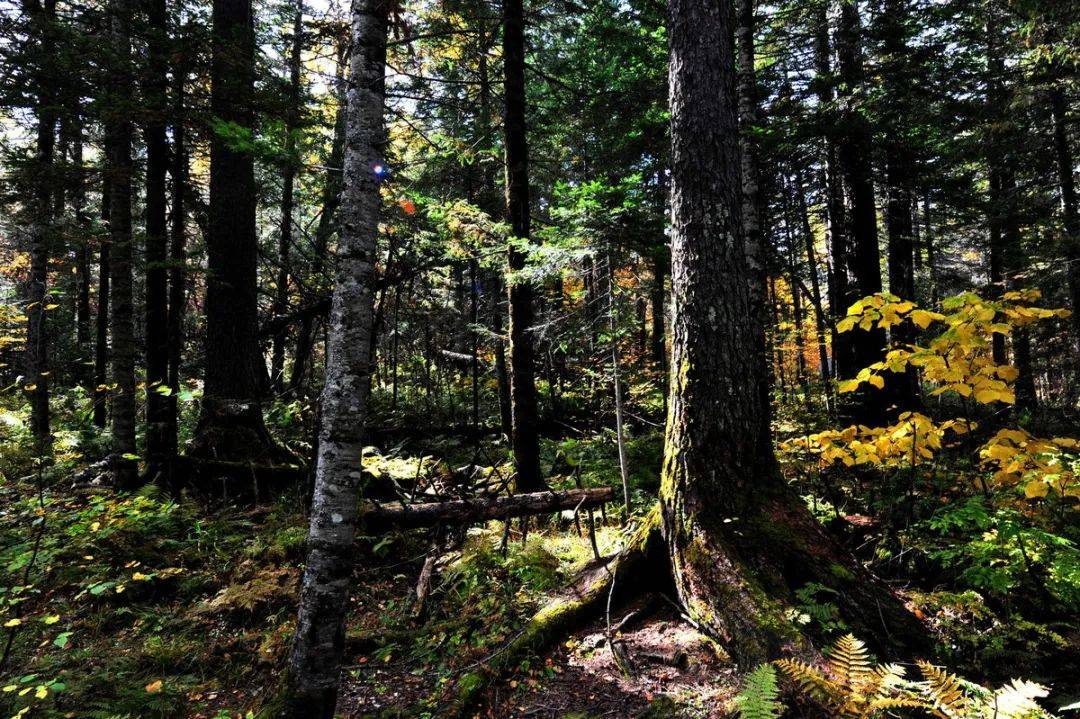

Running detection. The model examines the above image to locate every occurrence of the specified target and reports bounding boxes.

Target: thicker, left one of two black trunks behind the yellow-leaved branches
[836,0,886,380]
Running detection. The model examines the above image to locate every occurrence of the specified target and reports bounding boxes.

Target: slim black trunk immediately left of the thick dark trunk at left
[164,50,188,455]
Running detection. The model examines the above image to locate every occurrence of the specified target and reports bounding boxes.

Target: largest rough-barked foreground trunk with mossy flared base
[660,0,922,668]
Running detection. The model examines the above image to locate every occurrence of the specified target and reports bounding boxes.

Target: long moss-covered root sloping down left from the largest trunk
[436,512,661,718]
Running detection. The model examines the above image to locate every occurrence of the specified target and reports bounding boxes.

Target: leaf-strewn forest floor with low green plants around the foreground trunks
[0,427,1080,719]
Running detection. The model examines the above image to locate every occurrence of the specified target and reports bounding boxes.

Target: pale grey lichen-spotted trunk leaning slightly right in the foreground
[282,0,389,719]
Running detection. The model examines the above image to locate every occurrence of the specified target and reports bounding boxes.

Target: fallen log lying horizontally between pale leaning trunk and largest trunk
[361,487,615,534]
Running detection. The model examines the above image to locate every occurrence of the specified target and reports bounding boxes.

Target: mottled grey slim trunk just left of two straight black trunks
[104,0,138,488]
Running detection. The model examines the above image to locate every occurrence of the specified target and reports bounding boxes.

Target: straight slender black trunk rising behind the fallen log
[502,0,546,492]
